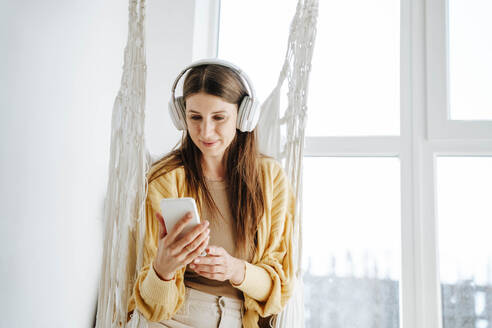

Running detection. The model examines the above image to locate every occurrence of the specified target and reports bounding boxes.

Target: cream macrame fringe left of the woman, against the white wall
[96,0,149,328]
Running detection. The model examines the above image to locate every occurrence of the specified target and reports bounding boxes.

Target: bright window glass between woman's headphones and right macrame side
[218,0,297,102]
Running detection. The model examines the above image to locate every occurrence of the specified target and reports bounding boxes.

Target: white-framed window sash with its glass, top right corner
[425,0,492,140]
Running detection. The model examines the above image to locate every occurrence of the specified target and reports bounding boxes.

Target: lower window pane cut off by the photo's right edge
[436,157,492,328]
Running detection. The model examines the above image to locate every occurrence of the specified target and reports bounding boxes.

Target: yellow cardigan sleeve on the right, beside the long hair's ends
[235,160,295,317]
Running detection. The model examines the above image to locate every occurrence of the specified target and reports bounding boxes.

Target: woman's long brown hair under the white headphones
[148,64,264,256]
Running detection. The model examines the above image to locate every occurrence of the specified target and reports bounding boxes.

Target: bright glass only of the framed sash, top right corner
[449,0,492,120]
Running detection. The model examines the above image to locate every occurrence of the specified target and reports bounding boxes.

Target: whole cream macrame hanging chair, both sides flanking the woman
[96,0,318,328]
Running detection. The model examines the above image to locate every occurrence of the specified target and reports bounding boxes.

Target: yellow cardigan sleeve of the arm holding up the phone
[128,174,185,322]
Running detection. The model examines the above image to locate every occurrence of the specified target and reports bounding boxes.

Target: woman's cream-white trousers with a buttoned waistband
[149,287,243,328]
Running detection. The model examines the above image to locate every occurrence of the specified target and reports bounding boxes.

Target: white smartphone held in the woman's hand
[161,197,200,238]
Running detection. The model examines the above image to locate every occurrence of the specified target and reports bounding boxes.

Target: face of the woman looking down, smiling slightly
[186,92,237,160]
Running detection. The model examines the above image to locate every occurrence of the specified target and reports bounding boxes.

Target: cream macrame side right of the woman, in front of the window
[258,0,318,328]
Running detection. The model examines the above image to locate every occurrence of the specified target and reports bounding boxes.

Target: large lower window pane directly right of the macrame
[303,157,401,328]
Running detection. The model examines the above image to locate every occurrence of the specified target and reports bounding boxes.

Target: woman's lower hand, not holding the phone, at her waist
[189,246,246,285]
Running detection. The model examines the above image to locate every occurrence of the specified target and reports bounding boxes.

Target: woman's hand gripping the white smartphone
[154,212,210,280]
